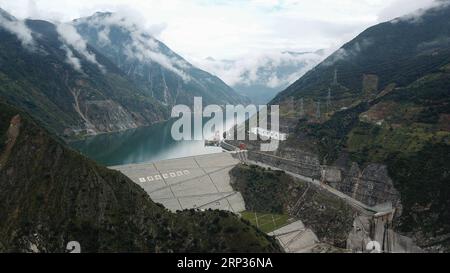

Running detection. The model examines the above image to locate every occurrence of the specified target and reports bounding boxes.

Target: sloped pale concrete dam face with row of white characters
[111,153,245,213]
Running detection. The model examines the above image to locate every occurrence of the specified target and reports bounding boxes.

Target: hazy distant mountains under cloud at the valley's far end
[198,50,327,105]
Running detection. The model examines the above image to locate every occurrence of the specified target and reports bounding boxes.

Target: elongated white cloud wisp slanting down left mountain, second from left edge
[56,23,104,71]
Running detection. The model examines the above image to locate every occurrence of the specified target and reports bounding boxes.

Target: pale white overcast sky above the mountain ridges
[0,0,440,62]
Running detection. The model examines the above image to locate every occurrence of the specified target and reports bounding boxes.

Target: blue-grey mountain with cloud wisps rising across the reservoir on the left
[0,8,247,138]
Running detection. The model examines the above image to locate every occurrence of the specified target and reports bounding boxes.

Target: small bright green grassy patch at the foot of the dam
[241,211,290,233]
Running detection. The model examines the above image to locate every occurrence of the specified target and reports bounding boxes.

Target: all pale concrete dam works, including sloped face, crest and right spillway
[110,148,414,253]
